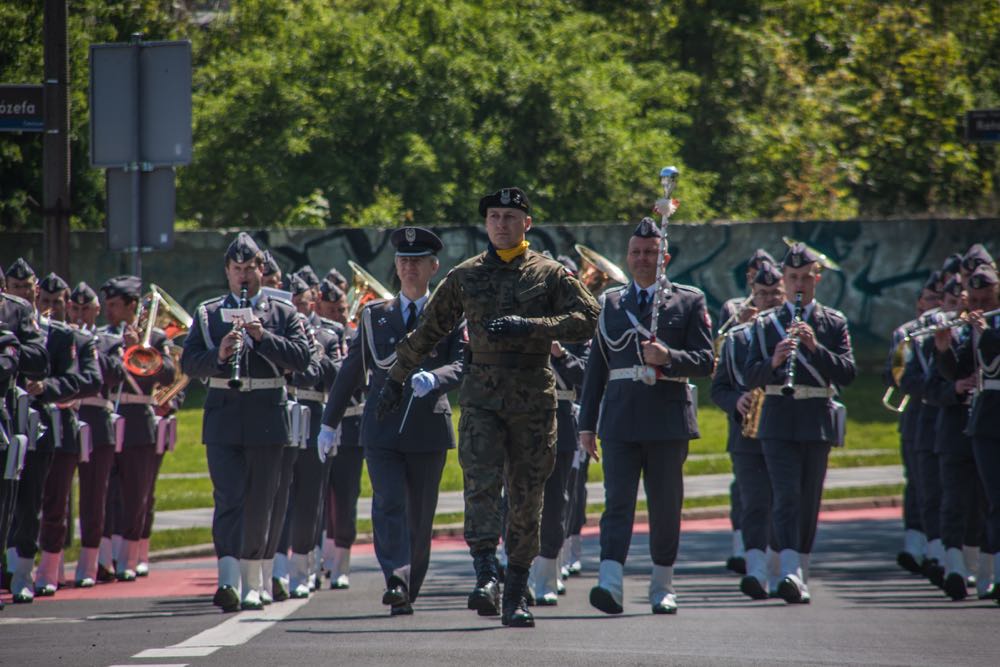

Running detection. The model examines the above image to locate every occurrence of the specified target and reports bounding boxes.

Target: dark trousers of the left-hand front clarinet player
[205,444,287,560]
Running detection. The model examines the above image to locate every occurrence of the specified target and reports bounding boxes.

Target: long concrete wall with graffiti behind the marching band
[0,220,1000,362]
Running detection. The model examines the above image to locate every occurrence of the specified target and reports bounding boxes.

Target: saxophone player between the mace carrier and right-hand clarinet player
[712,261,785,600]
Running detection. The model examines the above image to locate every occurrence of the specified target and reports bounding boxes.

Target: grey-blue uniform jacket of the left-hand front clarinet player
[181,294,312,447]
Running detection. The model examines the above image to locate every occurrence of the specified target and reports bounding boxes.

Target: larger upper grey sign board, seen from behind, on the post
[90,41,191,167]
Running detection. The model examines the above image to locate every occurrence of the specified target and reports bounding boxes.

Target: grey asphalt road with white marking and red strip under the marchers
[0,509,1000,667]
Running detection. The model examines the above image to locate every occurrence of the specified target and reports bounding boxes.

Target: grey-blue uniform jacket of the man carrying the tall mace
[579,281,712,442]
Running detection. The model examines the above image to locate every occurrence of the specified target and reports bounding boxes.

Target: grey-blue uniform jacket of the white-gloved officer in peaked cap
[323,297,466,452]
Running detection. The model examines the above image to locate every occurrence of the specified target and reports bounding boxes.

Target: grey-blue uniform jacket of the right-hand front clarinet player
[744,300,856,443]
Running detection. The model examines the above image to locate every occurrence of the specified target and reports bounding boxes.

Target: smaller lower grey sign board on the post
[106,167,175,250]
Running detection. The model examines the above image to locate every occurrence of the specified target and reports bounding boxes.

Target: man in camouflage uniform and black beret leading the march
[378,188,599,627]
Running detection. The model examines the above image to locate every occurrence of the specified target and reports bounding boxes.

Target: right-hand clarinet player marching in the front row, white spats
[744,243,856,603]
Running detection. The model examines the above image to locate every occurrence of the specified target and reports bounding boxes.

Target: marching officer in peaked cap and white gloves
[320,227,466,616]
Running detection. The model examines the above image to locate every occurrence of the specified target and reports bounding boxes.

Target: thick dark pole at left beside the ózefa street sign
[42,0,72,282]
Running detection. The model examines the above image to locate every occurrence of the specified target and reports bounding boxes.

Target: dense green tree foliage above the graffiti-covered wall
[0,0,1000,229]
